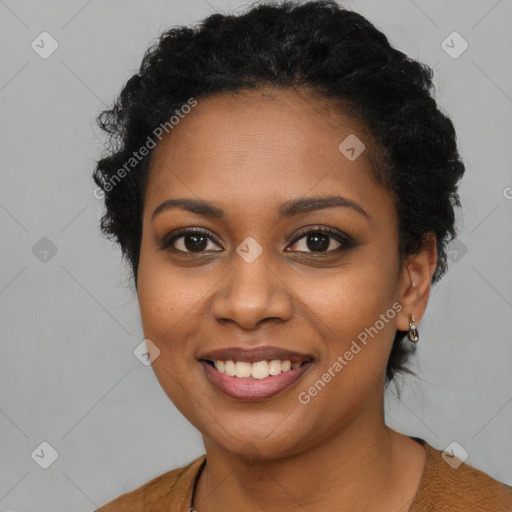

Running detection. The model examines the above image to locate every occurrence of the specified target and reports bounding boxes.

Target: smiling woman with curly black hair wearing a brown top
[94,1,512,512]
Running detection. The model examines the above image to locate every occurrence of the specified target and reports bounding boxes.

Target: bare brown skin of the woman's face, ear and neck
[138,90,436,512]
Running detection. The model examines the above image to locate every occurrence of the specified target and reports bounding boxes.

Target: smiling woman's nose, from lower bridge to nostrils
[211,250,293,329]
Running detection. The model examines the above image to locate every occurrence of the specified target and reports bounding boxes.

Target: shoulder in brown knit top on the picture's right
[411,441,512,512]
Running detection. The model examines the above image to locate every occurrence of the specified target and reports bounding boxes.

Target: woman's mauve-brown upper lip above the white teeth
[198,345,314,363]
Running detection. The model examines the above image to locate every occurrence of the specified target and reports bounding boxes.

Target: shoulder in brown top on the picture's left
[96,455,206,512]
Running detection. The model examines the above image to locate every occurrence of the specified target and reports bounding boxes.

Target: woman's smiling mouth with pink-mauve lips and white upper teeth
[198,346,314,401]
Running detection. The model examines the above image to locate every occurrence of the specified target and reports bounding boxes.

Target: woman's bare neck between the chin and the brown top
[193,400,424,512]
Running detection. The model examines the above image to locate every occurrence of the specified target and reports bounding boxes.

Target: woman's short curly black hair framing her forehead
[93,0,464,382]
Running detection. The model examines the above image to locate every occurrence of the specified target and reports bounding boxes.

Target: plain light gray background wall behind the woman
[0,0,512,512]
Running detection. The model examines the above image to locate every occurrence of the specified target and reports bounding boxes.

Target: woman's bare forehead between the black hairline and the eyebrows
[146,89,392,223]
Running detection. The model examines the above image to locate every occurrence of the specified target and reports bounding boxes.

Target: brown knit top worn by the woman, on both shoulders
[96,438,512,512]
